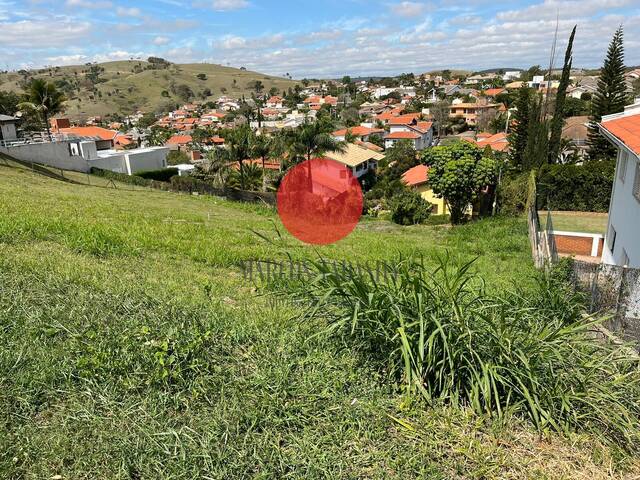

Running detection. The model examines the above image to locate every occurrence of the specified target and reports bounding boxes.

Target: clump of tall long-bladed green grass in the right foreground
[294,258,640,450]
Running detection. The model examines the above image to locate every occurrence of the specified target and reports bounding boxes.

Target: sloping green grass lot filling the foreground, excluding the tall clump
[0,165,640,479]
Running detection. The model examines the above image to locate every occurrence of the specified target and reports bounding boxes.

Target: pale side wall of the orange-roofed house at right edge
[602,145,640,268]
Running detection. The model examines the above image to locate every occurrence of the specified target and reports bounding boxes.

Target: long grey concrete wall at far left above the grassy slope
[0,141,89,172]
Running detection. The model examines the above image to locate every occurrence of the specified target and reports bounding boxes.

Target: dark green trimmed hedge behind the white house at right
[538,161,616,212]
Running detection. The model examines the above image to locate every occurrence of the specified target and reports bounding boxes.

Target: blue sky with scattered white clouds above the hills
[0,0,640,78]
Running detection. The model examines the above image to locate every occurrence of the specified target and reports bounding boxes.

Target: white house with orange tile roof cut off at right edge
[600,102,640,268]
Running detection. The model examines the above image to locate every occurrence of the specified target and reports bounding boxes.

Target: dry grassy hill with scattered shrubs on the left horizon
[0,60,296,118]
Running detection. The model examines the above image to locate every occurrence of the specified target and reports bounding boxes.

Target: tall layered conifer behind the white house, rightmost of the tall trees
[587,26,628,160]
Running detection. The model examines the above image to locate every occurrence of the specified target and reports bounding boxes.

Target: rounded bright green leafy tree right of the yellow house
[422,142,498,225]
